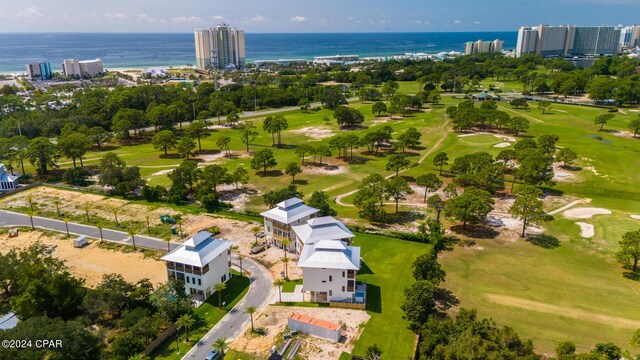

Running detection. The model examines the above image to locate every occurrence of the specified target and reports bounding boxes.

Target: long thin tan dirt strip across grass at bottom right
[484,294,640,329]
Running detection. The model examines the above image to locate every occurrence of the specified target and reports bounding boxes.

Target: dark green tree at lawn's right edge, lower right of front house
[400,280,436,332]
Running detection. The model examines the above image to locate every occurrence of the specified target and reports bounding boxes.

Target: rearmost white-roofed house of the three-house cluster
[260,198,320,252]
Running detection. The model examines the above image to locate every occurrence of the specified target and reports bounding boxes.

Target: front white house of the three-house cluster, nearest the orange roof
[298,240,360,302]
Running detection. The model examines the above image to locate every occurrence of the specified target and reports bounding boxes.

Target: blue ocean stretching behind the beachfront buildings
[0,32,517,73]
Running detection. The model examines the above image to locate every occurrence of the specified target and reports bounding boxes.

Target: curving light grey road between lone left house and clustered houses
[182,258,273,360]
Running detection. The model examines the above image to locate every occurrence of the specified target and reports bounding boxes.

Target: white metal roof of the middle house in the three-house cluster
[291,216,355,252]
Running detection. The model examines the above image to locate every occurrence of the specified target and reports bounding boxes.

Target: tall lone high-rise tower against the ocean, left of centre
[194,24,246,69]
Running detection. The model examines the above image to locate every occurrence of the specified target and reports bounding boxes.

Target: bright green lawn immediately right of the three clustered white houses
[353,233,430,359]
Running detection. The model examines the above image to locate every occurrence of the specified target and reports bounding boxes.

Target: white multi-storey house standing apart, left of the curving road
[162,231,232,300]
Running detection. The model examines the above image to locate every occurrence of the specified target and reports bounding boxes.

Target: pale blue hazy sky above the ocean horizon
[0,0,640,32]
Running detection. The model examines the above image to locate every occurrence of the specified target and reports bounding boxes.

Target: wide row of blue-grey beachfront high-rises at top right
[516,25,631,57]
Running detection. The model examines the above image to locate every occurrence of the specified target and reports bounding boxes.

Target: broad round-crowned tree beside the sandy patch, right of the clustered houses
[445,188,494,228]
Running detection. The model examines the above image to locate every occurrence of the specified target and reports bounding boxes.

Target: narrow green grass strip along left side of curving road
[152,271,249,360]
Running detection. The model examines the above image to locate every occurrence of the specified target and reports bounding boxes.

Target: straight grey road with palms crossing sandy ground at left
[0,210,178,251]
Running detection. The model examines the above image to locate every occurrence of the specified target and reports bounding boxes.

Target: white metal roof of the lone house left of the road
[162,231,233,267]
